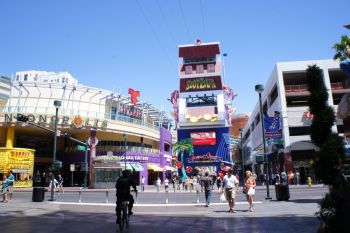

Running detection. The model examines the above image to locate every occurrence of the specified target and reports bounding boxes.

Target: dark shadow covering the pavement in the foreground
[0,209,319,233]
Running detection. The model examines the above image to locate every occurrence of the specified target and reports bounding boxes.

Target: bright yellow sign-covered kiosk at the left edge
[0,147,35,188]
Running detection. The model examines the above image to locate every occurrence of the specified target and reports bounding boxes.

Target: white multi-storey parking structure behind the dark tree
[243,60,350,182]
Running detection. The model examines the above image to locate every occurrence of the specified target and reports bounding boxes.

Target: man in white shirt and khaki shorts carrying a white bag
[222,168,239,213]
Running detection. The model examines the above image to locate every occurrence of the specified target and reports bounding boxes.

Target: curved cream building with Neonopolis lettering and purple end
[0,71,174,188]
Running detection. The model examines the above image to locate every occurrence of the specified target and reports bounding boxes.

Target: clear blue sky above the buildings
[0,0,350,112]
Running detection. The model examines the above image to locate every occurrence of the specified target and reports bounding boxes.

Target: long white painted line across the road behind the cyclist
[49,201,262,207]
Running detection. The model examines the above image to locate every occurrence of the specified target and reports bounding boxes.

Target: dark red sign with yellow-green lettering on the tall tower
[180,76,222,92]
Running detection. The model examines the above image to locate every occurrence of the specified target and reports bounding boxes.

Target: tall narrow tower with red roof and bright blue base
[172,40,234,179]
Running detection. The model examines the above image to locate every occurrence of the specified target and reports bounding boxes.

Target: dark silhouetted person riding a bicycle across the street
[115,170,137,224]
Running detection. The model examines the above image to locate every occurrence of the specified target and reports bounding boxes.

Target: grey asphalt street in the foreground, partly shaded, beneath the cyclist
[0,187,326,233]
